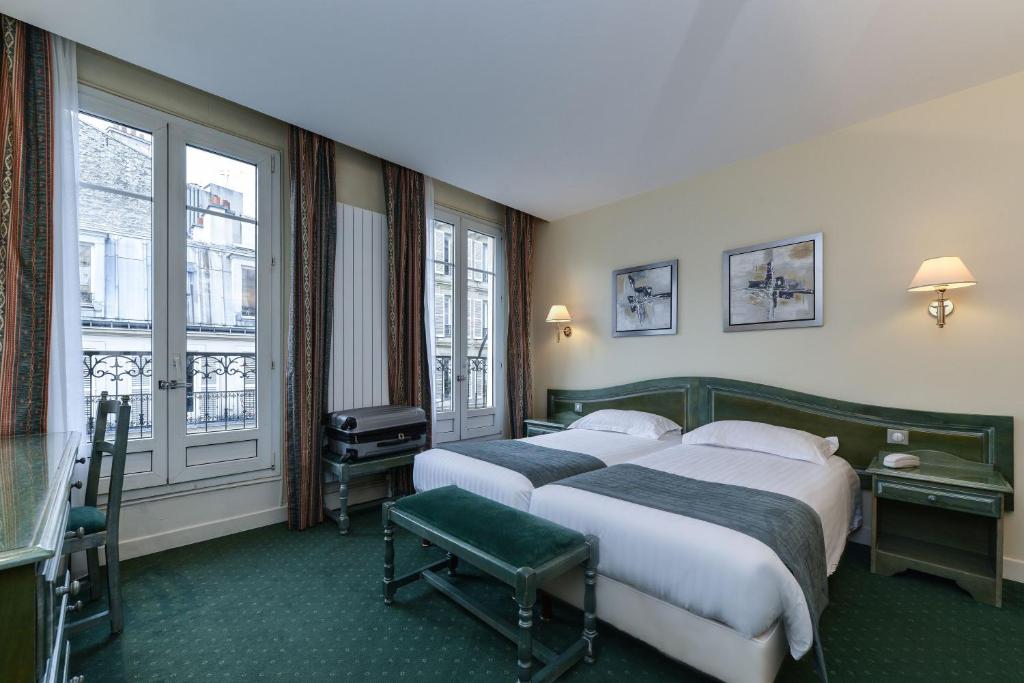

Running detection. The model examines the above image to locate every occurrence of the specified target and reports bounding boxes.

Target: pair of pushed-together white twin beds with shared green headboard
[405,378,1012,681]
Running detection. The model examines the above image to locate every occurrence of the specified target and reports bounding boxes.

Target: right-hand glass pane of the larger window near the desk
[184,146,259,432]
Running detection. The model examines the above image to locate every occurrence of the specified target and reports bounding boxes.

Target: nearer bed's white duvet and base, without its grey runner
[529,445,861,681]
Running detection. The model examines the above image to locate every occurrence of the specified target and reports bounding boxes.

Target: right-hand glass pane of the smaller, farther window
[466,230,495,409]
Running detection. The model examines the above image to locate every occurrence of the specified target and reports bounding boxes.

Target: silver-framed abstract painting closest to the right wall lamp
[722,232,824,332]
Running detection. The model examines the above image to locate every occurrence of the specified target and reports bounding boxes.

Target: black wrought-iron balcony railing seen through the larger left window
[83,351,257,438]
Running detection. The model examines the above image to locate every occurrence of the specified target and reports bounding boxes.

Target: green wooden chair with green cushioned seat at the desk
[63,391,131,634]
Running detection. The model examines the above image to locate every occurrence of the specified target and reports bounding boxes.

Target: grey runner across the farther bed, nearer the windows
[437,439,604,488]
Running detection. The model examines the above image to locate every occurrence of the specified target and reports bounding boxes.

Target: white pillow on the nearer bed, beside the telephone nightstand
[682,420,839,465]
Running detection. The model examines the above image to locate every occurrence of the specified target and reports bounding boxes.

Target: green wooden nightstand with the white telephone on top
[867,451,1013,607]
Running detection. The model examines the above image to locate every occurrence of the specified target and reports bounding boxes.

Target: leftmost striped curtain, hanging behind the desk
[0,15,53,435]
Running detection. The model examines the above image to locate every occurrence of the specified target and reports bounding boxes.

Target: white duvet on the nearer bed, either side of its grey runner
[529,445,860,657]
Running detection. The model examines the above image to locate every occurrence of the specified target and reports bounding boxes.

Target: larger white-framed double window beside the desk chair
[79,87,281,488]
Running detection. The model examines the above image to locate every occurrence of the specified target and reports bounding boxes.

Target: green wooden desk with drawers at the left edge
[0,432,81,683]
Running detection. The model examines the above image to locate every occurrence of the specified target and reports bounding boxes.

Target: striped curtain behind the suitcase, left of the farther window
[384,161,431,494]
